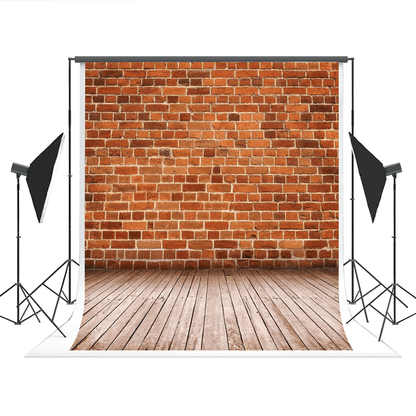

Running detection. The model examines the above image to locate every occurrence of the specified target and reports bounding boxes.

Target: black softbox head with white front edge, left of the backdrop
[26,133,64,222]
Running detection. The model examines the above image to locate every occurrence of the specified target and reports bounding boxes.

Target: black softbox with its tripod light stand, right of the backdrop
[347,135,416,341]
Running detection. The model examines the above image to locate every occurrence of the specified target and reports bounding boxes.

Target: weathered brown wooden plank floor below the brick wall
[72,269,351,350]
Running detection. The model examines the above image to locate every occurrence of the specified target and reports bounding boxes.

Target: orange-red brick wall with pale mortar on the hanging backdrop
[85,62,339,268]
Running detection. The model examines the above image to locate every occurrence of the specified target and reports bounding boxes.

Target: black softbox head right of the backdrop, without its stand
[350,133,386,222]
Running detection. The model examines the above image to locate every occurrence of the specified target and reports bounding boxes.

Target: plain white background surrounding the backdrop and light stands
[0,0,416,415]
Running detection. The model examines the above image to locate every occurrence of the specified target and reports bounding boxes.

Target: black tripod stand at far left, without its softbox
[0,163,65,337]
